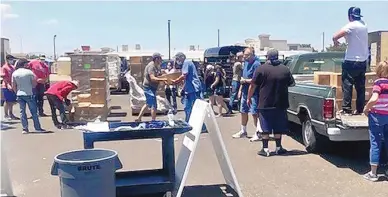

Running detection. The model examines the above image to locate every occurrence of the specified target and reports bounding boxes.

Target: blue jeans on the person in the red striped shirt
[368,113,388,165]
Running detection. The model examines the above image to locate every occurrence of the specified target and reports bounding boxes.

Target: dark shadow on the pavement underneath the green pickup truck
[288,121,387,175]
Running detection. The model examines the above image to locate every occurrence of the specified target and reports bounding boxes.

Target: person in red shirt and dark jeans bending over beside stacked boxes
[45,81,78,129]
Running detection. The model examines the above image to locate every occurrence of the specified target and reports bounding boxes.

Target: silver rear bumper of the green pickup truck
[327,127,369,141]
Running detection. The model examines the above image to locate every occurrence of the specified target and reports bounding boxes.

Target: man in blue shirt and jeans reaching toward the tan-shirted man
[172,52,202,122]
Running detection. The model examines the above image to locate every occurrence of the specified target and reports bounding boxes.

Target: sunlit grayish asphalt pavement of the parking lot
[1,95,388,197]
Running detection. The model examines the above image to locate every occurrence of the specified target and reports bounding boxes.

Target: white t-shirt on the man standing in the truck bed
[342,20,369,62]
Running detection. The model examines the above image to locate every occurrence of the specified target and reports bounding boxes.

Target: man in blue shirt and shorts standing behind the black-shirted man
[233,48,260,141]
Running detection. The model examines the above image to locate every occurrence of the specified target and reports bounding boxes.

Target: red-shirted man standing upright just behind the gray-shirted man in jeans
[29,55,50,116]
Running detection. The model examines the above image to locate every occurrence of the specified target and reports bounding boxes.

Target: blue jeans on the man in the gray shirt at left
[17,95,42,130]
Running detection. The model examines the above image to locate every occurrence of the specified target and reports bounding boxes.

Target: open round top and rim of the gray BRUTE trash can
[54,148,118,164]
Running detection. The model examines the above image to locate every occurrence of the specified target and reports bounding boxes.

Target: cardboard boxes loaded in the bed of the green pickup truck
[314,72,377,109]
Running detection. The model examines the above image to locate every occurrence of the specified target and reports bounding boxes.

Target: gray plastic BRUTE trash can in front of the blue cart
[51,149,122,197]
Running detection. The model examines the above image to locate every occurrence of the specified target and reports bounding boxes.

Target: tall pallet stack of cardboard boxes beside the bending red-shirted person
[71,54,110,121]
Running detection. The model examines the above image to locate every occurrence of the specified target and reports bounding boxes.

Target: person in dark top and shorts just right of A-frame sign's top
[210,65,229,117]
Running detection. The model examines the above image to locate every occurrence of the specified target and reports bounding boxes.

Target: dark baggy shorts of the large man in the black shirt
[259,109,289,134]
